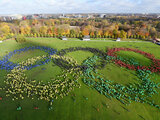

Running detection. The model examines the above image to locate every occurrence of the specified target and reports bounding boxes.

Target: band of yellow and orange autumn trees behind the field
[0,18,160,40]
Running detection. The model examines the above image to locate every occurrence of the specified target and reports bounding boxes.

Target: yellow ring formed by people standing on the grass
[5,55,80,101]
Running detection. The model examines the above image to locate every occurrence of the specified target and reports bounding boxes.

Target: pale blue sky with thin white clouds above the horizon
[0,0,160,14]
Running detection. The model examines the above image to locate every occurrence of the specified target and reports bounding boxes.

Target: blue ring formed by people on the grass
[0,46,57,71]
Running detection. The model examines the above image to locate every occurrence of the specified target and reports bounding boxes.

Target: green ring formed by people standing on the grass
[81,56,160,109]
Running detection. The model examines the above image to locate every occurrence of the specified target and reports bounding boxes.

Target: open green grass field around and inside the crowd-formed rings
[0,38,160,120]
